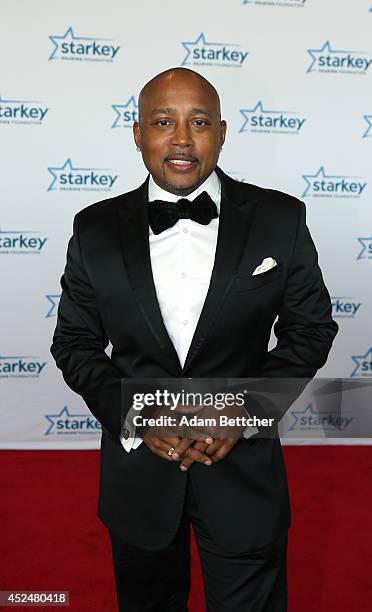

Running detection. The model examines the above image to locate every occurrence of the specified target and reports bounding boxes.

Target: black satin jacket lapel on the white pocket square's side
[181,168,258,376]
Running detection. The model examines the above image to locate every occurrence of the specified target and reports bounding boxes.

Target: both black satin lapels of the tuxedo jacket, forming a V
[118,168,258,377]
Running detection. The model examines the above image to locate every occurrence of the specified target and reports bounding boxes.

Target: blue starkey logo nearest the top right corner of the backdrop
[307,40,372,74]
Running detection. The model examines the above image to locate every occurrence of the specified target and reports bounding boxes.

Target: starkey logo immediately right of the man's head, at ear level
[239,100,306,134]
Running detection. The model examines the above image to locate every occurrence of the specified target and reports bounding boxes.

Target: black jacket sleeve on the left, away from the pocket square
[50,215,125,440]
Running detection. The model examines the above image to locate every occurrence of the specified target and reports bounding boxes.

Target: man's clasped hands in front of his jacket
[141,406,246,472]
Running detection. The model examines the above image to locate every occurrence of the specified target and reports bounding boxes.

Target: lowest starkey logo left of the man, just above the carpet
[44,406,102,436]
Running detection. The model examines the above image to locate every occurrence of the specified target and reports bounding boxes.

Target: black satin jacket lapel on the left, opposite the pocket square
[118,179,181,376]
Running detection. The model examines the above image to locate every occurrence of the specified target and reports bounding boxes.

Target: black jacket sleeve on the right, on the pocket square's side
[248,202,338,422]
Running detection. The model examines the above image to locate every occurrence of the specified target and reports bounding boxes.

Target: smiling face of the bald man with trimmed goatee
[133,73,226,196]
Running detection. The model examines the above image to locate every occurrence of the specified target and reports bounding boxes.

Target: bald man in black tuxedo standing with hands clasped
[51,68,337,612]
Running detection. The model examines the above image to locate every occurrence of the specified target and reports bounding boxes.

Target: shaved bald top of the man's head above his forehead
[138,67,221,121]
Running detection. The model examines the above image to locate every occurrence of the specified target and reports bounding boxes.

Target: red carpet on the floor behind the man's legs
[0,446,372,612]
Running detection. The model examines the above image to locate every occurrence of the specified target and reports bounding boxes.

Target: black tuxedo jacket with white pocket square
[51,169,337,551]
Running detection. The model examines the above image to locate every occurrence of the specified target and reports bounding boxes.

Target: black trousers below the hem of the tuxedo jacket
[109,474,287,612]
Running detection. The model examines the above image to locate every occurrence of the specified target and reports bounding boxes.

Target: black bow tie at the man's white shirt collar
[148,191,218,234]
